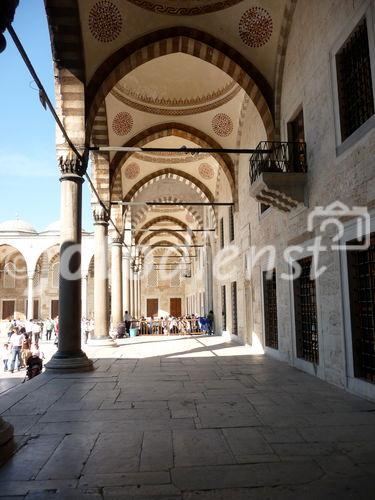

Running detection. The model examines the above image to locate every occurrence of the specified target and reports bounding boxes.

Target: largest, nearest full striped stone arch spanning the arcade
[87,26,274,145]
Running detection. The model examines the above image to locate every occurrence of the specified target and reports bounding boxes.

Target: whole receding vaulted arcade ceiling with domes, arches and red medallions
[46,0,296,264]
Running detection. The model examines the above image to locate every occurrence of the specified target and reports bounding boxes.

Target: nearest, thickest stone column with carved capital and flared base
[46,155,93,371]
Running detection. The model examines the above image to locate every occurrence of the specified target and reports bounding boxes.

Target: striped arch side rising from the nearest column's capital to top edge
[44,0,85,147]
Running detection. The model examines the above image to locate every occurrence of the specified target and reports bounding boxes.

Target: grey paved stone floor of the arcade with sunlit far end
[0,337,375,500]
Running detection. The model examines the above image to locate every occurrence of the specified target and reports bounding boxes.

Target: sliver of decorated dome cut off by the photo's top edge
[128,0,242,16]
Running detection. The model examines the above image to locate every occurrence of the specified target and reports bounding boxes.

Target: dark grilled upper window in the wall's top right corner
[336,18,374,141]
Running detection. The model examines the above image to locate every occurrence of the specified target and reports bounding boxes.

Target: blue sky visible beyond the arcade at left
[0,0,92,231]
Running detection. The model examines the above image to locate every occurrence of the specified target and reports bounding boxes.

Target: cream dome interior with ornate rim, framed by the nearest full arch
[111,53,241,116]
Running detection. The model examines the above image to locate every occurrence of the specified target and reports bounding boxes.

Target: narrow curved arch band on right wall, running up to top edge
[274,0,297,140]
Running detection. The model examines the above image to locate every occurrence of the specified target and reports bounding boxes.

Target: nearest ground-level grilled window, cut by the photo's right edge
[347,233,375,384]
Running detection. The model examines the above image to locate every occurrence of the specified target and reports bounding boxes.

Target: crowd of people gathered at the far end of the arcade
[117,311,214,337]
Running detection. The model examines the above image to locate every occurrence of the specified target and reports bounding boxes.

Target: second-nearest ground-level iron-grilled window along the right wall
[294,257,319,364]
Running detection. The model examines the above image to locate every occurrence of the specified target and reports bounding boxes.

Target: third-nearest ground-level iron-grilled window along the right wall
[263,269,279,349]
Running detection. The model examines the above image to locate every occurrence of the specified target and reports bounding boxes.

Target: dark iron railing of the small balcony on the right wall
[250,141,307,184]
